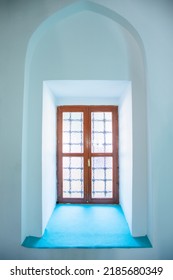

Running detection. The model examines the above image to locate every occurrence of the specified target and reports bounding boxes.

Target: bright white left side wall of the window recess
[42,83,57,233]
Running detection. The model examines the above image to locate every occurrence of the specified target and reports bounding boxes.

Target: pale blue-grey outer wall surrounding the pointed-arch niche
[0,0,173,259]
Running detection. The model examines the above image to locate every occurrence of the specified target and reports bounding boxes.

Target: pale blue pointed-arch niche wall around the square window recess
[22,1,147,240]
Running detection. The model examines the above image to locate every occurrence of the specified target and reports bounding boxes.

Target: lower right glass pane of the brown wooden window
[91,157,113,198]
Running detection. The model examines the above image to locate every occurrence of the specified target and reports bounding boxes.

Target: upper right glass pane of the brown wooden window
[91,112,112,153]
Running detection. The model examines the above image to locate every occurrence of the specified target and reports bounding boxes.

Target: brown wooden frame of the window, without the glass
[57,105,119,204]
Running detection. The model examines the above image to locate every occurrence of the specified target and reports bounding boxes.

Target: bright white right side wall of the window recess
[119,84,132,234]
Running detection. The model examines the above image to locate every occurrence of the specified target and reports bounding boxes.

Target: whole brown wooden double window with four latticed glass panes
[57,106,118,203]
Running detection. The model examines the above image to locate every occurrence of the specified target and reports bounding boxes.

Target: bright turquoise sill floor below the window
[22,204,151,248]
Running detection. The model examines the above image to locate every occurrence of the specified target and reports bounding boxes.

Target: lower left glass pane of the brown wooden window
[63,157,84,198]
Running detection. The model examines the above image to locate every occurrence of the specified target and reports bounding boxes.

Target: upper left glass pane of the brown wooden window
[62,112,83,153]
